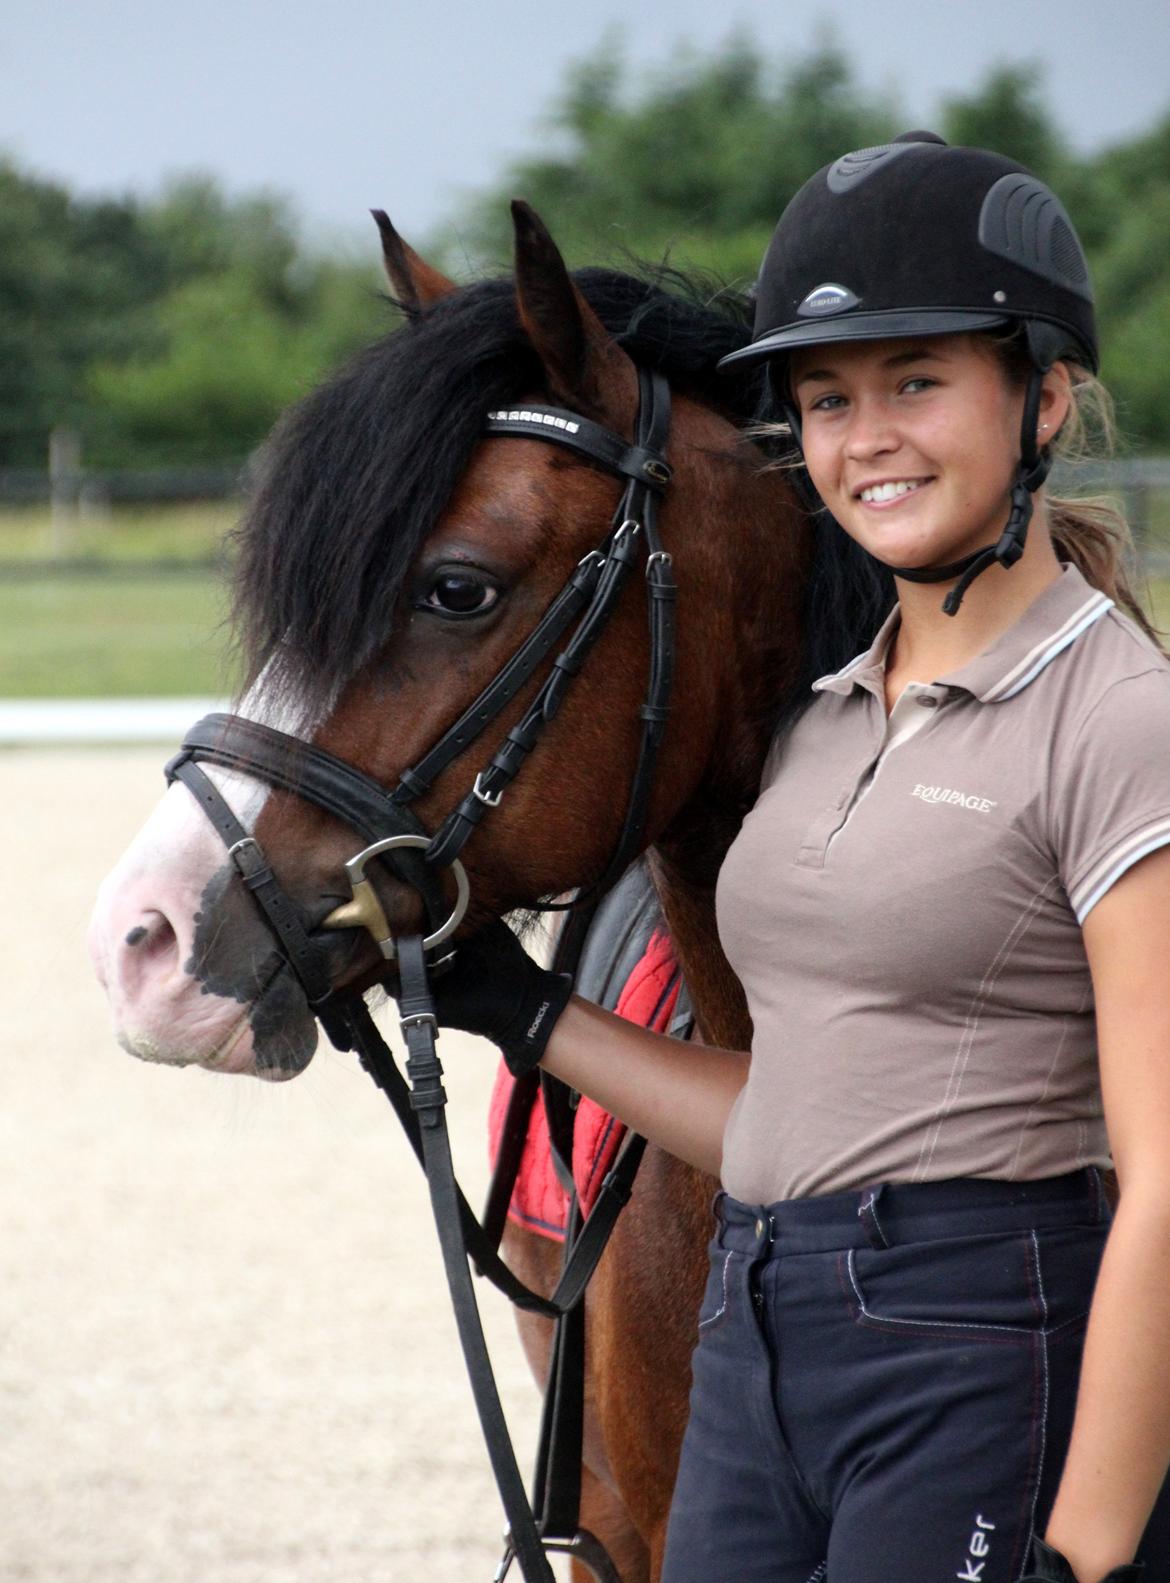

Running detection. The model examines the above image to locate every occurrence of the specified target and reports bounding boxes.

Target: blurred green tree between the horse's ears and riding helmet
[445,36,896,280]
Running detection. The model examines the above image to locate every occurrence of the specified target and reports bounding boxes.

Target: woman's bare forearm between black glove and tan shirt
[541,996,749,1176]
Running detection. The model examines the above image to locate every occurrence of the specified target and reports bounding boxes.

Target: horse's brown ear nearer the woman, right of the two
[511,198,638,432]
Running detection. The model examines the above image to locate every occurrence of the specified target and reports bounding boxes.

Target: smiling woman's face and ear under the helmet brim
[790,336,1067,567]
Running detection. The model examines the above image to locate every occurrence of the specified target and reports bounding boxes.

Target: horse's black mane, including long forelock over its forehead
[234,269,888,718]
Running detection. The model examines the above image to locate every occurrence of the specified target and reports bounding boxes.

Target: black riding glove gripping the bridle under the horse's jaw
[431,918,573,1076]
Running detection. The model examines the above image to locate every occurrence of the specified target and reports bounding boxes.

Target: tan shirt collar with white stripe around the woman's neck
[812,565,1113,703]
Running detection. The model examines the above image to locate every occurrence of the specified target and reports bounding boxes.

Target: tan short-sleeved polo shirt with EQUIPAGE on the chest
[716,567,1170,1203]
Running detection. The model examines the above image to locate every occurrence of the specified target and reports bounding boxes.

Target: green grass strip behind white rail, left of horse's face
[0,568,240,698]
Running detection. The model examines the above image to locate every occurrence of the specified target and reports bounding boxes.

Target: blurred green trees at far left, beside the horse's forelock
[0,163,393,469]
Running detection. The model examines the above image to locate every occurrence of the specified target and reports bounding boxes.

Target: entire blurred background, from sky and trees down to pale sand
[0,0,1170,1583]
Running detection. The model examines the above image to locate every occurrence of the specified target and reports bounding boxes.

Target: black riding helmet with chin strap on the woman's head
[720,131,1097,616]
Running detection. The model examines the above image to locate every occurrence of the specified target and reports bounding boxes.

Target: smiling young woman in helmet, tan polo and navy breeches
[439,133,1170,1583]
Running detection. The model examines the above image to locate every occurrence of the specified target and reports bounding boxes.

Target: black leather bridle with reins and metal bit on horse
[166,369,676,1583]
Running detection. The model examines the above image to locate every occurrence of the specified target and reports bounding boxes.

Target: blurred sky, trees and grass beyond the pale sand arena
[0,0,1170,706]
